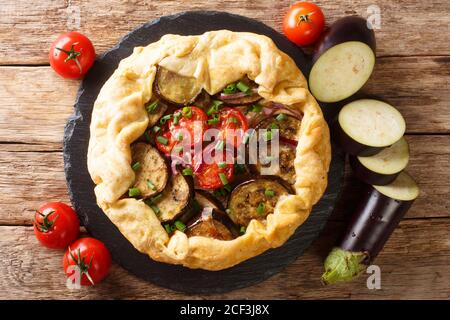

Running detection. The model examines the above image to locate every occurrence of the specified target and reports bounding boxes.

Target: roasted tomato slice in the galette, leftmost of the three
[156,106,208,155]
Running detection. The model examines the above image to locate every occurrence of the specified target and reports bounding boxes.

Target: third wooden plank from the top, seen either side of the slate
[0,135,450,225]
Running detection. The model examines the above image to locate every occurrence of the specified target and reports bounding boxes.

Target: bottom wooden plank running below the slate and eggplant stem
[0,219,450,299]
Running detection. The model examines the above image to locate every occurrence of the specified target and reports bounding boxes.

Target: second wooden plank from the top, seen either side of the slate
[0,57,450,146]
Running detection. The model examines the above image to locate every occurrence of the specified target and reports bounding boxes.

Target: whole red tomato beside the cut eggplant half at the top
[283,2,325,46]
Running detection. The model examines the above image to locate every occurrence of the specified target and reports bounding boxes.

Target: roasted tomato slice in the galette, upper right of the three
[214,108,248,148]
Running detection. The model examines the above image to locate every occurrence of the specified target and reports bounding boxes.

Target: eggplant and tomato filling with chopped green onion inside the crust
[124,67,302,240]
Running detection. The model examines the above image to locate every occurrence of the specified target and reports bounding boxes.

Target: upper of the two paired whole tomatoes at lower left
[34,202,80,249]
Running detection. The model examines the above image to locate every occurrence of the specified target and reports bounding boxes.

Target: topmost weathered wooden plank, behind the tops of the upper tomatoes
[0,0,450,64]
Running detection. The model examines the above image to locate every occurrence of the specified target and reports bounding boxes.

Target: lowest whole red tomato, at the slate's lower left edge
[63,238,111,286]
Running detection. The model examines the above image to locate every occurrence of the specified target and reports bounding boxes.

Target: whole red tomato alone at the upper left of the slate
[48,31,95,79]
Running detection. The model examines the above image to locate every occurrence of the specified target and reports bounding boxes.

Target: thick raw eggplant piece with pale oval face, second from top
[336,99,406,156]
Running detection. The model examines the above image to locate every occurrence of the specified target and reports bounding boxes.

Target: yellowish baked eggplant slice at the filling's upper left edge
[155,67,202,105]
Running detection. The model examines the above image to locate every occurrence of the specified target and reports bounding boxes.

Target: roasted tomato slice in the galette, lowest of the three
[194,141,234,190]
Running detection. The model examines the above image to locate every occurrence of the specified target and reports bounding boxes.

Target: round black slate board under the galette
[64,11,344,293]
